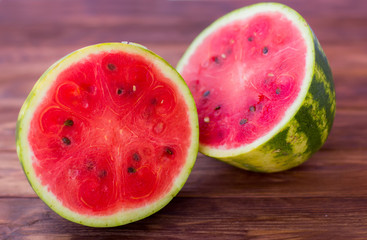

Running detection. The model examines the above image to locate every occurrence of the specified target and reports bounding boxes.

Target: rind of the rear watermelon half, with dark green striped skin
[176,3,335,172]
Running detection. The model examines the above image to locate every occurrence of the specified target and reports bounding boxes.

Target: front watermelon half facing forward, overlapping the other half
[17,43,199,227]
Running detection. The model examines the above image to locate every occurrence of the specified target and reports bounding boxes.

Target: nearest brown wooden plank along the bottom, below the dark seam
[0,197,367,239]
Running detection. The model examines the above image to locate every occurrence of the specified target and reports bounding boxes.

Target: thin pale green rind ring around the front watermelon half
[16,43,199,227]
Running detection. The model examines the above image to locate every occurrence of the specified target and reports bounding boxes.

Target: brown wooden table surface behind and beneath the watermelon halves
[0,0,367,239]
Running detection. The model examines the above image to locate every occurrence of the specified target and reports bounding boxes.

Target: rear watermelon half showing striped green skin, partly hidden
[177,3,335,172]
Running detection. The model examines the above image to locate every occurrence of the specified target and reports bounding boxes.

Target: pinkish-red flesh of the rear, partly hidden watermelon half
[182,12,307,149]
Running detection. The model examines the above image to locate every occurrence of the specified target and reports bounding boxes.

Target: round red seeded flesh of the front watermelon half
[29,52,191,215]
